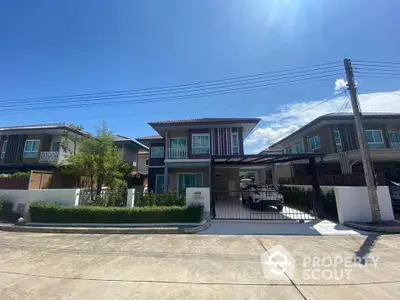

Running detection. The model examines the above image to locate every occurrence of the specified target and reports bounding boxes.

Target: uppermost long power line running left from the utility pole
[1,62,340,103]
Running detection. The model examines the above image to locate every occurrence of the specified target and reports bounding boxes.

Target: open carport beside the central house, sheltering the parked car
[210,153,324,220]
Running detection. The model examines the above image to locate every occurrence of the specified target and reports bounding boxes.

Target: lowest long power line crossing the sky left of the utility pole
[1,73,342,112]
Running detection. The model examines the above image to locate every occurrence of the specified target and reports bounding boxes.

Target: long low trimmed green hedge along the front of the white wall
[29,202,203,223]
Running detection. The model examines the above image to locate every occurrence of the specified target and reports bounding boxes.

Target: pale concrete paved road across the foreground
[0,232,400,300]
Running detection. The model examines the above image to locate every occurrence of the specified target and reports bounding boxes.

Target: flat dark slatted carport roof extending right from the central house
[211,153,324,166]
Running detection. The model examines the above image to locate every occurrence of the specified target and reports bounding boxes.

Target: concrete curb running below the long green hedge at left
[0,220,211,234]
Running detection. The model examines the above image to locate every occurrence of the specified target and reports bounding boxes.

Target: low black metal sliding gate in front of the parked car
[211,189,317,221]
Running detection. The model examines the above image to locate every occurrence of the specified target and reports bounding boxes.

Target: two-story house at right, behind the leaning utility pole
[261,113,400,183]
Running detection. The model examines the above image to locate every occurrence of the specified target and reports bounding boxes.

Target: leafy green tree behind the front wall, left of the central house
[62,122,132,202]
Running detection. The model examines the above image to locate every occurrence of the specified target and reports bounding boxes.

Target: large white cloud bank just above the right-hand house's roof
[245,91,400,153]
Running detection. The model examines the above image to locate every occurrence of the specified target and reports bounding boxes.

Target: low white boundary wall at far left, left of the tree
[0,189,80,213]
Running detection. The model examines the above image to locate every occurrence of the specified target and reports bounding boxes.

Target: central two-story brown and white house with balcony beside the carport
[137,118,260,193]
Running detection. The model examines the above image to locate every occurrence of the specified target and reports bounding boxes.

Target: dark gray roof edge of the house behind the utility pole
[268,112,400,148]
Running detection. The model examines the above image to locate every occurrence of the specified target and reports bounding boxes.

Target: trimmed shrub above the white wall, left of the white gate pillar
[135,190,186,207]
